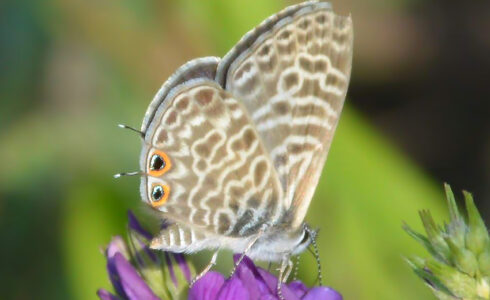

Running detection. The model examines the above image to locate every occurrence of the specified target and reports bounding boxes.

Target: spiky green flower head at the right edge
[404,185,490,300]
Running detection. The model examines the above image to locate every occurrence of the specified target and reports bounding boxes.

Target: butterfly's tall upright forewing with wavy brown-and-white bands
[217,2,353,226]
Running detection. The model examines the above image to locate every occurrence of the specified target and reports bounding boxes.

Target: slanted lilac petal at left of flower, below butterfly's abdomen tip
[114,253,158,300]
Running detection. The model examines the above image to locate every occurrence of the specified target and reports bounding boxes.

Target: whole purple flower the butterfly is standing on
[97,212,342,300]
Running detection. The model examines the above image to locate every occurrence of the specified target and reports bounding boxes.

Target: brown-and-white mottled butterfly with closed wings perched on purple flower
[131,1,353,288]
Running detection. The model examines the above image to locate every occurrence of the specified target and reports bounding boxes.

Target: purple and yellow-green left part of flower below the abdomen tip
[97,212,194,300]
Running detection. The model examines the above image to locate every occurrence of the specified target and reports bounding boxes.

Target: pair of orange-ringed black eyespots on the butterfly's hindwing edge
[141,149,172,209]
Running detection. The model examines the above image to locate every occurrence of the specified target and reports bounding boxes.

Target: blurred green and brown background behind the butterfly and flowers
[0,0,490,299]
